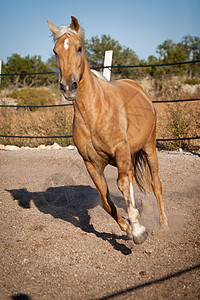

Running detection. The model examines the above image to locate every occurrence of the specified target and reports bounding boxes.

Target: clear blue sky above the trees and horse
[0,0,200,62]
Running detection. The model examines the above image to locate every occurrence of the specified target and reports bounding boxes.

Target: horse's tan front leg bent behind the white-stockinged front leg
[85,161,132,238]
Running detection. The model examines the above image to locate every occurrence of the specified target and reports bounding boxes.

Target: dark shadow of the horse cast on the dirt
[7,185,131,255]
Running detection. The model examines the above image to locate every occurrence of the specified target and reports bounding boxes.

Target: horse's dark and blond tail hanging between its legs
[132,149,153,192]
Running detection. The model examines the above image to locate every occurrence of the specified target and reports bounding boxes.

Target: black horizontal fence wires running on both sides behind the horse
[0,60,200,142]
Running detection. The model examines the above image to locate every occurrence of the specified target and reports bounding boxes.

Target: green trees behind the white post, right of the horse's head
[84,35,200,80]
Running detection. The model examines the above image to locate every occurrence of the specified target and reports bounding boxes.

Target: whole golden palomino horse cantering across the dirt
[47,17,167,244]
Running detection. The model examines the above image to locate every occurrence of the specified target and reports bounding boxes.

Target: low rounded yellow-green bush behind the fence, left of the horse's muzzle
[9,88,55,111]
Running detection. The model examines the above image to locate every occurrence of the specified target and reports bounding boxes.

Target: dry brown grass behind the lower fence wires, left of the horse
[0,107,73,147]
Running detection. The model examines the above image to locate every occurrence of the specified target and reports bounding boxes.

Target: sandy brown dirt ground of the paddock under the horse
[0,149,200,300]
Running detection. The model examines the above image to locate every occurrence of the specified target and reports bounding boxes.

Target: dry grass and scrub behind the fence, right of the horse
[154,85,200,150]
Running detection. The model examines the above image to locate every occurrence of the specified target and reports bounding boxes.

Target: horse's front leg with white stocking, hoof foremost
[116,147,148,244]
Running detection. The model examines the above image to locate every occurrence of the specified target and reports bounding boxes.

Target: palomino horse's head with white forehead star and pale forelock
[47,17,84,100]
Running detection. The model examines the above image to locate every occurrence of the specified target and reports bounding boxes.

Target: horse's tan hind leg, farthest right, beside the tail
[145,140,168,227]
